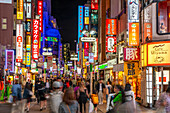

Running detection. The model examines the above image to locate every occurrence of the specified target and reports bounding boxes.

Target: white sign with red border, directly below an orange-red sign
[106,36,116,53]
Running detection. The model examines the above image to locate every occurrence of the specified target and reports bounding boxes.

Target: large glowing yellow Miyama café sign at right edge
[148,41,170,66]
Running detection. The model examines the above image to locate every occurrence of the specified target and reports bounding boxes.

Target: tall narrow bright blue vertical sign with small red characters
[78,6,84,43]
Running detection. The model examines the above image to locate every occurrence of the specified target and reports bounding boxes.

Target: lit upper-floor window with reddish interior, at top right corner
[157,0,170,34]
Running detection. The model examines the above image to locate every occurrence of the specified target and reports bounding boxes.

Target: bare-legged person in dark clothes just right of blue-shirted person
[23,84,32,112]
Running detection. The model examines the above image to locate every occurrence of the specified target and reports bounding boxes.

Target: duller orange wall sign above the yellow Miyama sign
[143,23,152,43]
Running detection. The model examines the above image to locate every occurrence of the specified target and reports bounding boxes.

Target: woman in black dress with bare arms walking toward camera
[78,82,89,113]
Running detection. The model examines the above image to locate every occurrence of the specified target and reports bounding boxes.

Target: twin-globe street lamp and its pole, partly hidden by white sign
[82,28,96,94]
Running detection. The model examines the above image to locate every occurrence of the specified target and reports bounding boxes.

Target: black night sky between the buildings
[51,0,87,50]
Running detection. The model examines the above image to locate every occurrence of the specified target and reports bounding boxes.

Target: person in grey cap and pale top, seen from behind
[48,81,64,113]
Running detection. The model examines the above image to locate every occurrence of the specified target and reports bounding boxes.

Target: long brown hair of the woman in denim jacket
[63,88,75,105]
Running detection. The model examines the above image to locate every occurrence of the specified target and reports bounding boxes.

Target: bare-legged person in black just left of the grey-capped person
[38,84,47,111]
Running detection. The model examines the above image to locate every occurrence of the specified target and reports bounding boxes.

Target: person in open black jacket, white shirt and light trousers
[96,79,105,104]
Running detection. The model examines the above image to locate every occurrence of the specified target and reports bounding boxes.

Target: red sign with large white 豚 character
[124,48,140,61]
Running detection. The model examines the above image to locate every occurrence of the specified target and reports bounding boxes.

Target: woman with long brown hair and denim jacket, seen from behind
[58,88,79,113]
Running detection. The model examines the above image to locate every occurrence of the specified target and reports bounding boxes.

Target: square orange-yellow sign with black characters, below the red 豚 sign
[124,62,139,76]
